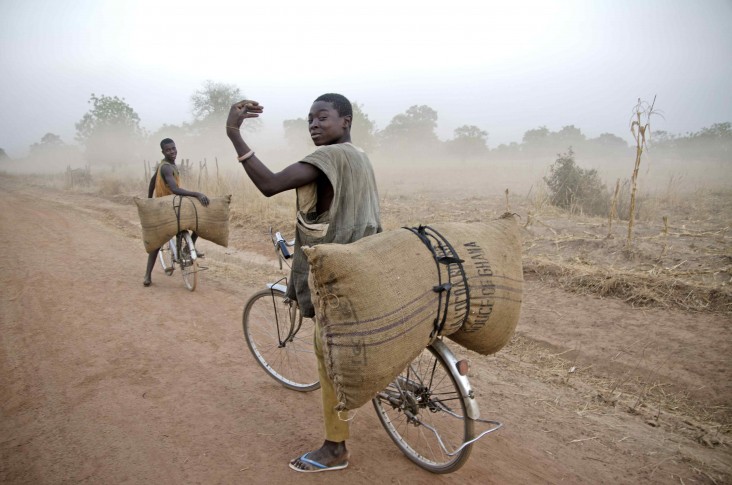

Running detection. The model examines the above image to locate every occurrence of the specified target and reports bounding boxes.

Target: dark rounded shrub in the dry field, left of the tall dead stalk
[544,147,610,216]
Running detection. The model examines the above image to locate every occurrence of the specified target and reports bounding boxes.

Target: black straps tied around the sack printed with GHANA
[404,226,470,340]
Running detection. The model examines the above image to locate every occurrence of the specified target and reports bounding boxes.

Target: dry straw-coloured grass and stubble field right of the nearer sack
[524,183,732,313]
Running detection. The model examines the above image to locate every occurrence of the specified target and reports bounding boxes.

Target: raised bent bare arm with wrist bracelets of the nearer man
[226,100,320,197]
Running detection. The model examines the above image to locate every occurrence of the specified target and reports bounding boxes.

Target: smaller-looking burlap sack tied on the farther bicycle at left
[135,195,231,253]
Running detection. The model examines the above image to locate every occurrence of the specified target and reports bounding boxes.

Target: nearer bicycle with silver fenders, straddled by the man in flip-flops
[242,229,502,474]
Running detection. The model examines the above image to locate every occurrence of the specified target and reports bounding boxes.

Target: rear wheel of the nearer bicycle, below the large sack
[372,346,474,473]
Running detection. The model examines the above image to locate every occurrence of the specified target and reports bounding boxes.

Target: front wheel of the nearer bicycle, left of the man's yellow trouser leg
[242,288,320,391]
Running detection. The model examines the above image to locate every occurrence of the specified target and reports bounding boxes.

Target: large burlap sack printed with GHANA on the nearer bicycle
[303,215,523,410]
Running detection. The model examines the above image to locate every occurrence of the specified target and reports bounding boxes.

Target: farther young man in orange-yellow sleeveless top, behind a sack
[142,138,208,286]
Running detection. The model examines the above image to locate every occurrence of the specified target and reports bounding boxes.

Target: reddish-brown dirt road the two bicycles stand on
[0,177,730,484]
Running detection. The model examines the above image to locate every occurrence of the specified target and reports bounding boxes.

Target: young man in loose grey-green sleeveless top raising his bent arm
[226,93,381,472]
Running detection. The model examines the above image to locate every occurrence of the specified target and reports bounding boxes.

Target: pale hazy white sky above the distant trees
[0,0,732,157]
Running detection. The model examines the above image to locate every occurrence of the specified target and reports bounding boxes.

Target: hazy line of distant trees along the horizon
[0,81,732,165]
